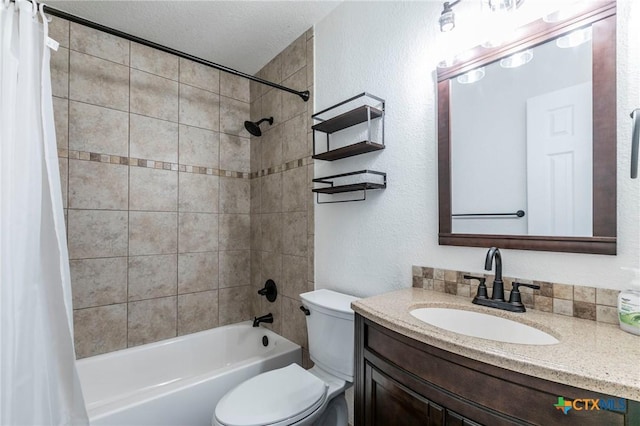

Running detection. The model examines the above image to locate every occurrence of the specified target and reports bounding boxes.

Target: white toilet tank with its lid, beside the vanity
[300,289,358,382]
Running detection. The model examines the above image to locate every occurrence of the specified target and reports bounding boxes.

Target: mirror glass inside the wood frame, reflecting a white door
[450,27,593,237]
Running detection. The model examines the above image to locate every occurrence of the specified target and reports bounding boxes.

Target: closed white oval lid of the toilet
[215,364,327,426]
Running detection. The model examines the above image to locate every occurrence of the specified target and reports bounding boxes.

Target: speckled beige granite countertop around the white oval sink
[352,288,640,401]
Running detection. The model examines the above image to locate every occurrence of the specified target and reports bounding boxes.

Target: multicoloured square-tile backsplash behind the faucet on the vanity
[412,266,620,324]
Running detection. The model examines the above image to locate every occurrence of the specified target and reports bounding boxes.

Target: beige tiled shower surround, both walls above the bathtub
[51,15,276,357]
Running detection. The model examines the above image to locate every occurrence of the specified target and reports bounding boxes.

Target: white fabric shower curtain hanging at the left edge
[0,0,88,426]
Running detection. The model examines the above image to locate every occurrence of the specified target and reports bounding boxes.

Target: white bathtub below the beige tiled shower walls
[77,322,301,426]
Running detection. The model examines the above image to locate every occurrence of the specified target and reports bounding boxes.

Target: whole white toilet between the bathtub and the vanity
[212,290,357,426]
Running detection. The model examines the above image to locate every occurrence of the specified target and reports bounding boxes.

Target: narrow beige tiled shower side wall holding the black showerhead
[250,30,314,366]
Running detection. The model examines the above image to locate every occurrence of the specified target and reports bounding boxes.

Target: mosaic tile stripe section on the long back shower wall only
[58,149,249,179]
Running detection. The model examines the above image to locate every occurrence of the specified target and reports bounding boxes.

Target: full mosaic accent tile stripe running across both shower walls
[58,149,313,179]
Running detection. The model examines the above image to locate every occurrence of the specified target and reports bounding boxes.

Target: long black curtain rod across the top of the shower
[10,0,309,102]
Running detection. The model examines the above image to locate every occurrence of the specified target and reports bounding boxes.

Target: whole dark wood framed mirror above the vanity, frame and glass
[437,1,617,255]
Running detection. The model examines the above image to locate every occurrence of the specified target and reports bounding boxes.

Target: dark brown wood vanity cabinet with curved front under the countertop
[355,315,640,426]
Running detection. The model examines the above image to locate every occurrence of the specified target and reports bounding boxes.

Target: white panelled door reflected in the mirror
[527,82,593,237]
